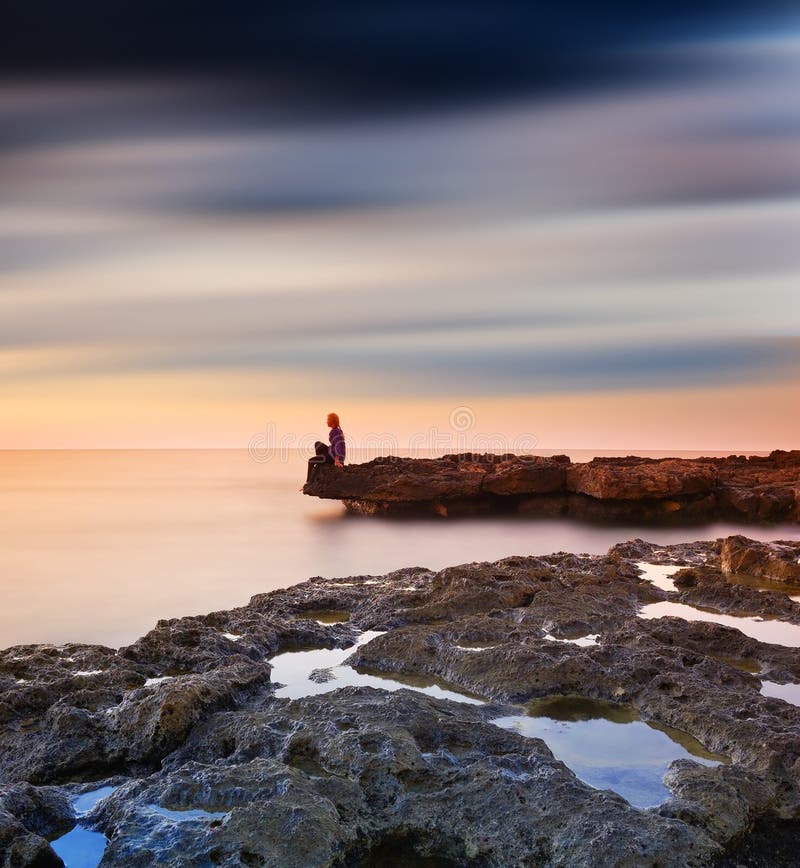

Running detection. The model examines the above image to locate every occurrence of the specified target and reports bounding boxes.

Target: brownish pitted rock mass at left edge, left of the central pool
[0,609,354,783]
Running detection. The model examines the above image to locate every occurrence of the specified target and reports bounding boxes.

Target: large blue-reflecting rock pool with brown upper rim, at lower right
[492,697,723,808]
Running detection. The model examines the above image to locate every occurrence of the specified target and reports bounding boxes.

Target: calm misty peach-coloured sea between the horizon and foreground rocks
[0,449,800,647]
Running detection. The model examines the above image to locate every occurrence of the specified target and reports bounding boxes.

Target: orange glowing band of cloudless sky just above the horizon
[0,373,800,454]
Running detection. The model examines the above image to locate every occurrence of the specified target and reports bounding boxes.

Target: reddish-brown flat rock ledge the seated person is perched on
[303,450,800,524]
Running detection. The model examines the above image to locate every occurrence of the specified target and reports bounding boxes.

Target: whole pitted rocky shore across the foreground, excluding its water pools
[0,537,800,868]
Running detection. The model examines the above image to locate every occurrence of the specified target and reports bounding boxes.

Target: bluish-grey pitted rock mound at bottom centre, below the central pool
[98,688,717,868]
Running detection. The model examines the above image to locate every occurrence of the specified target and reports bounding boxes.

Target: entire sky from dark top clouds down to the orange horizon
[0,2,800,451]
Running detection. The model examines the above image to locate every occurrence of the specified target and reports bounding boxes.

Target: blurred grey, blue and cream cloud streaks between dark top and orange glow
[0,32,800,448]
